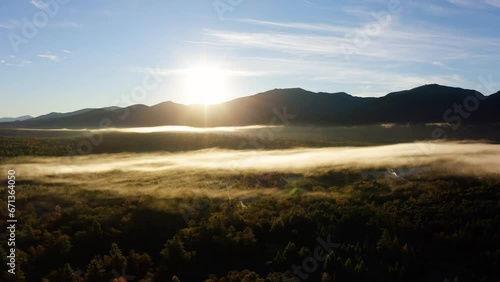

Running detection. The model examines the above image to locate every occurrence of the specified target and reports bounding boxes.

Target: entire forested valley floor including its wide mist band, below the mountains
[0,126,500,282]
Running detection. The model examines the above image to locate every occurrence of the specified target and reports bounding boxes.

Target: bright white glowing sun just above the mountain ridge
[184,65,227,104]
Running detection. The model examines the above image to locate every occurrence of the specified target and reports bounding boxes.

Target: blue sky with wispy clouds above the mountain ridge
[0,0,500,117]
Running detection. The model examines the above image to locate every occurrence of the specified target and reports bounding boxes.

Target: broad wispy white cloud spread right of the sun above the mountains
[196,19,500,96]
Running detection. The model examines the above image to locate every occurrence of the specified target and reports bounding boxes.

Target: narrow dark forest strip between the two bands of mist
[0,131,334,158]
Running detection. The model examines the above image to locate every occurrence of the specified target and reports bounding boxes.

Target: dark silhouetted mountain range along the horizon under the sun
[0,84,500,128]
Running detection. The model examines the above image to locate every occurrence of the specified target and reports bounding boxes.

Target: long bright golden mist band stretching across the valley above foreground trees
[1,142,500,177]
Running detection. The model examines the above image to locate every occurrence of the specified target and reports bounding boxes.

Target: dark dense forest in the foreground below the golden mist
[0,167,500,282]
